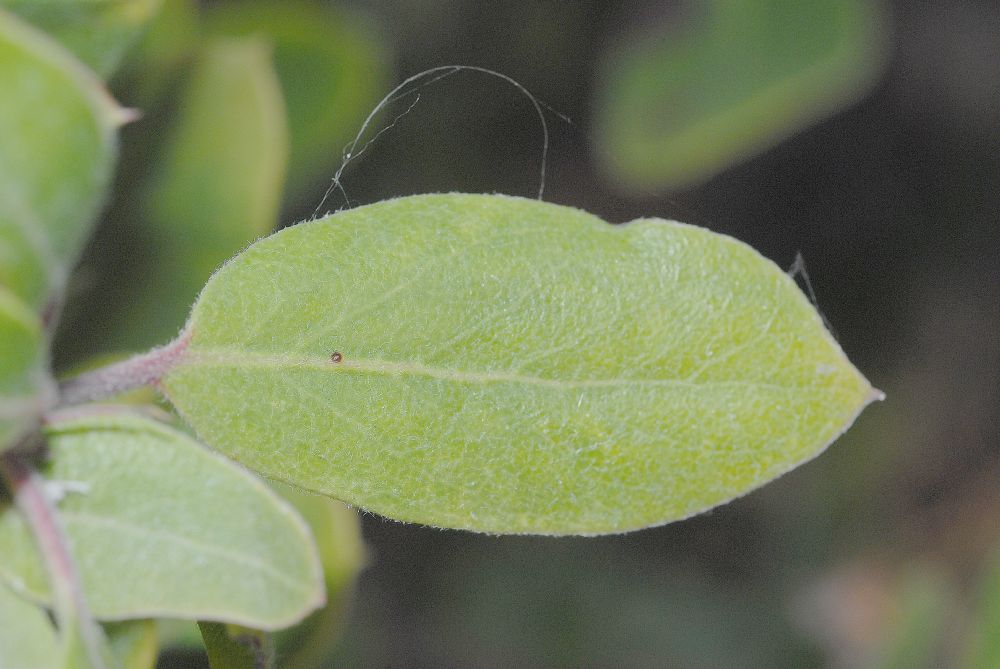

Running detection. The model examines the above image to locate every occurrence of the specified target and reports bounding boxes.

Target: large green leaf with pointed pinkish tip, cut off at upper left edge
[0,10,123,311]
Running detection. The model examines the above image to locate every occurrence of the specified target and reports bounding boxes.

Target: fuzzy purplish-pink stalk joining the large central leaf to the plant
[59,331,191,406]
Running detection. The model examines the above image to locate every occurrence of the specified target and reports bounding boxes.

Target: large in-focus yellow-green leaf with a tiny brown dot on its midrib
[160,194,878,534]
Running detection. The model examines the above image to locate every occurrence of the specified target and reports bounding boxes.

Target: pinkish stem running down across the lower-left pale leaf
[0,452,105,668]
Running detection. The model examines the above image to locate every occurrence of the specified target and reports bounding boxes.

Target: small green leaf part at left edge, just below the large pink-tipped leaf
[0,286,50,451]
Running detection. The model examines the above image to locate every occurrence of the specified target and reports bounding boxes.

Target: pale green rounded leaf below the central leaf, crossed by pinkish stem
[0,409,323,629]
